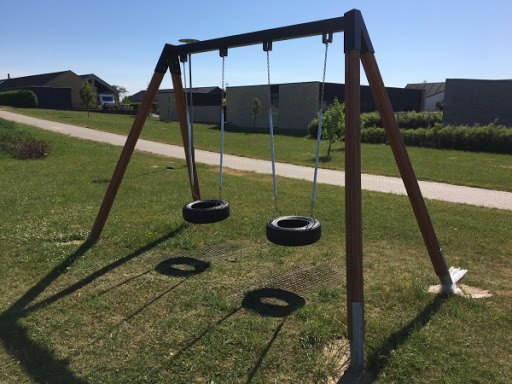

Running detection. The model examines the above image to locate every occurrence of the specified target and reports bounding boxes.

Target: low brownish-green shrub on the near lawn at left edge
[0,120,50,159]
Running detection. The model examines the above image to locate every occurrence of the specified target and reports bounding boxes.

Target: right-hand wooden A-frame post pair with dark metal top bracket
[344,10,453,371]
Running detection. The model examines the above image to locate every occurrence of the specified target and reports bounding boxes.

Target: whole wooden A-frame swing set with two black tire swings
[89,9,465,371]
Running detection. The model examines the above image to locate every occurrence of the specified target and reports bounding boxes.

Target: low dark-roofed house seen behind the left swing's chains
[157,87,222,124]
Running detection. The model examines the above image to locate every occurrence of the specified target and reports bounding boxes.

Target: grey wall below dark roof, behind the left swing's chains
[156,92,220,124]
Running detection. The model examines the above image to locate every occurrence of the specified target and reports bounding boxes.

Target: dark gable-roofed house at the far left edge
[0,71,82,109]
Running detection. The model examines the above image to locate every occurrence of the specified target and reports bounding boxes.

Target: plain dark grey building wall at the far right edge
[444,79,512,125]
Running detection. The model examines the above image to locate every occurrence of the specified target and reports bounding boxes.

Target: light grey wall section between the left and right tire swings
[226,85,270,131]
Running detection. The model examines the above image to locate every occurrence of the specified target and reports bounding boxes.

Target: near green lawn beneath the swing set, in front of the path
[0,121,512,384]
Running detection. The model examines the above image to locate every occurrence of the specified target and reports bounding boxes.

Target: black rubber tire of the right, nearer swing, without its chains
[267,216,322,247]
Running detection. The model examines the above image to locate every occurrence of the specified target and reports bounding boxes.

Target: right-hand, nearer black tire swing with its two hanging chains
[263,33,332,246]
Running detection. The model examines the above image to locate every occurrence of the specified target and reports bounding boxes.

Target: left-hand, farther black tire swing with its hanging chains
[181,49,230,224]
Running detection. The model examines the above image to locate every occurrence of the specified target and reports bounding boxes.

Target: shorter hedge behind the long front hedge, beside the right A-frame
[361,112,443,129]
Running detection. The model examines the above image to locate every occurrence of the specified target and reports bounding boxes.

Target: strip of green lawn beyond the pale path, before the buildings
[6,108,512,191]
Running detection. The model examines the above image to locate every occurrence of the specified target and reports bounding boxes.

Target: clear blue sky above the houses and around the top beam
[0,0,512,94]
